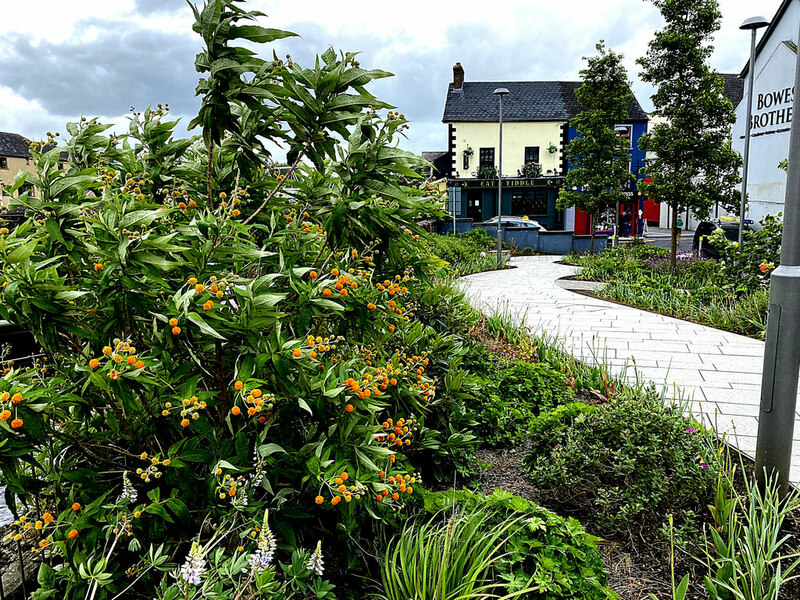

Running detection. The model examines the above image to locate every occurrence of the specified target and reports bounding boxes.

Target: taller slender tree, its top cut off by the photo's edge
[637,0,741,269]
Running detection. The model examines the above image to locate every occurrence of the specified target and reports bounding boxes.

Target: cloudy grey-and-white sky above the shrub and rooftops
[0,0,781,157]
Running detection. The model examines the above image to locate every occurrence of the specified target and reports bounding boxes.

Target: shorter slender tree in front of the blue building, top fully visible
[558,40,633,254]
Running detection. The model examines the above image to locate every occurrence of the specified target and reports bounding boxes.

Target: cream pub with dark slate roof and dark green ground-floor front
[432,63,647,230]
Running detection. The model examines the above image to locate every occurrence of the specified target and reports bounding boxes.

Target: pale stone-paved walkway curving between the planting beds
[461,256,800,483]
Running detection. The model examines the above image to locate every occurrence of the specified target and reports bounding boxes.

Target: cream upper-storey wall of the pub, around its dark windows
[448,121,562,178]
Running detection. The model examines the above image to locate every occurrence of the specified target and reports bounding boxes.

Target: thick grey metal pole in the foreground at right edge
[756,21,800,494]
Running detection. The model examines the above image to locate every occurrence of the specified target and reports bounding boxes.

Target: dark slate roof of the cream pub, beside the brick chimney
[442,81,647,123]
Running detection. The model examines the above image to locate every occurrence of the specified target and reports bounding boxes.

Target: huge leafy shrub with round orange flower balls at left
[0,0,484,599]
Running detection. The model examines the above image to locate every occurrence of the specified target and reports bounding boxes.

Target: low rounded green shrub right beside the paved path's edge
[525,396,718,536]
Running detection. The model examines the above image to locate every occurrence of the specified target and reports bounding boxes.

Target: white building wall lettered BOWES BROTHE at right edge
[733,1,800,222]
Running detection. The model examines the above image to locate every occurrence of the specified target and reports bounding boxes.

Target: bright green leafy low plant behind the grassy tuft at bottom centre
[418,490,618,600]
